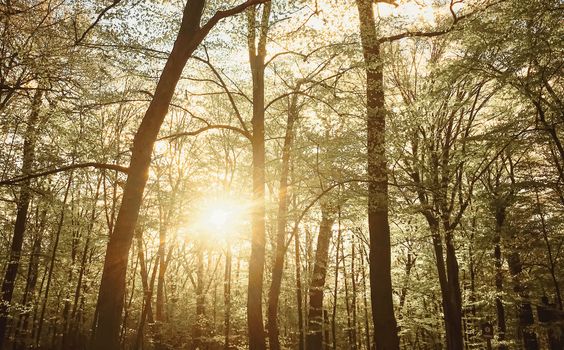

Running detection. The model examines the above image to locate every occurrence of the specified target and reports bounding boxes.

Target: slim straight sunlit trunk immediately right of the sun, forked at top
[247,3,270,350]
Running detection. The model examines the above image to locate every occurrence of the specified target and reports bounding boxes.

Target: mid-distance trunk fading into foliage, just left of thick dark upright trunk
[306,205,335,350]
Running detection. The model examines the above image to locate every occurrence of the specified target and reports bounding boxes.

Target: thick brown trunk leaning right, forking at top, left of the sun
[94,0,260,350]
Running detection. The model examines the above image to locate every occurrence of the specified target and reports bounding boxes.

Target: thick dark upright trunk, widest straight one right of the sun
[356,0,399,350]
